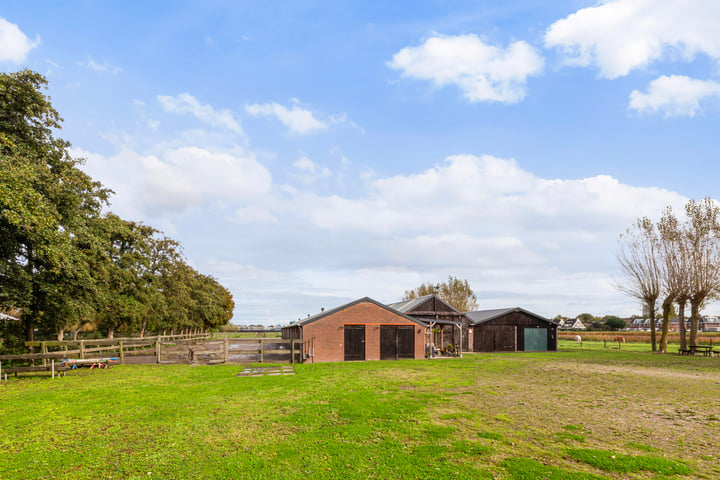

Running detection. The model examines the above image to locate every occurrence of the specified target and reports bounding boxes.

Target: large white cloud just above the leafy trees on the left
[73,143,272,218]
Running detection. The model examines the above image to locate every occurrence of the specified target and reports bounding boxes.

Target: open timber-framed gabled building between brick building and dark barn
[388,295,472,352]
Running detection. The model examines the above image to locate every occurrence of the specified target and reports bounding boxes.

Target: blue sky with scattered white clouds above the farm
[0,0,720,325]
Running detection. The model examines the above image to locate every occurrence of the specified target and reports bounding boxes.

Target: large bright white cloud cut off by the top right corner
[545,0,720,78]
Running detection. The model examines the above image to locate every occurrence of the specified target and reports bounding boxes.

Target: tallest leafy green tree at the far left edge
[0,70,110,340]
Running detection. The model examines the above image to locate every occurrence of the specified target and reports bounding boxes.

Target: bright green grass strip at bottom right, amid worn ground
[568,448,693,475]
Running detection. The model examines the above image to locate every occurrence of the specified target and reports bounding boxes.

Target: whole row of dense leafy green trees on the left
[0,70,234,340]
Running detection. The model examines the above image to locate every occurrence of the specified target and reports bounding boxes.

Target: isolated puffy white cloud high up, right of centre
[388,35,543,103]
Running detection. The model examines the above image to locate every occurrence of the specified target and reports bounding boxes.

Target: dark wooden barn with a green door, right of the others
[465,308,557,352]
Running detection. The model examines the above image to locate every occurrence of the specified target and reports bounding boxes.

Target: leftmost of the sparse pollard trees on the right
[617,217,662,352]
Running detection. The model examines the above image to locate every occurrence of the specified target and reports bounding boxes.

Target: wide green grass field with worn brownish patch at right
[0,342,720,479]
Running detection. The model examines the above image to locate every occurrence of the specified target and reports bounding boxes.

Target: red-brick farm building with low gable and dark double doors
[282,297,426,363]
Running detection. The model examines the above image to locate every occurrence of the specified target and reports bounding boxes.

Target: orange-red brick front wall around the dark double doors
[303,302,425,362]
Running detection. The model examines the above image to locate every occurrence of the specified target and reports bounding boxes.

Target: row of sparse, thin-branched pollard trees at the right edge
[617,198,720,352]
